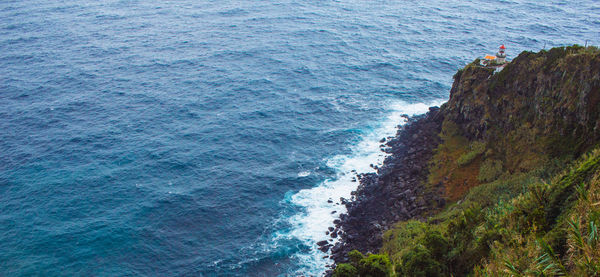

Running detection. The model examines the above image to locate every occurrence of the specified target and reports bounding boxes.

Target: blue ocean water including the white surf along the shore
[0,0,600,276]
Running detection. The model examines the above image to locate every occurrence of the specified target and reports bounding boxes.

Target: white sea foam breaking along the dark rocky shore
[284,101,442,276]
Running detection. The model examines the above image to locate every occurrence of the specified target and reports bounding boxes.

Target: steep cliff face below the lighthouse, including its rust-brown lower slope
[429,46,600,200]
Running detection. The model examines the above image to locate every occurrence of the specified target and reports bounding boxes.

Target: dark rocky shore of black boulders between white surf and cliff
[319,107,444,272]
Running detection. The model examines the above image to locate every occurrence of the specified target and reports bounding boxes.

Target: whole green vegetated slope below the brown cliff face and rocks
[344,146,600,276]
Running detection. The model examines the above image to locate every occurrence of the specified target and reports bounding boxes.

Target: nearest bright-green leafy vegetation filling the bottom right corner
[474,149,600,276]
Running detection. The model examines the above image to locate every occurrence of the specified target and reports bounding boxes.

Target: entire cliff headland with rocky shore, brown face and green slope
[332,46,600,276]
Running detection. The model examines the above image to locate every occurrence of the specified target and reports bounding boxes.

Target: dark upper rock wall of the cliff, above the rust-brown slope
[442,46,600,157]
